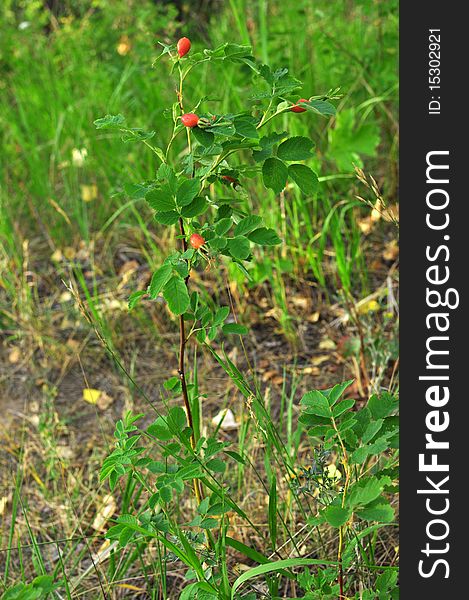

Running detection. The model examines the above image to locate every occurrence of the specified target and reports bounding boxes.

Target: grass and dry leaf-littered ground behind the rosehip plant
[0,0,398,598]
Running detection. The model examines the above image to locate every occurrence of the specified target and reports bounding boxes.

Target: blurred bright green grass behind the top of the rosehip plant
[0,0,397,296]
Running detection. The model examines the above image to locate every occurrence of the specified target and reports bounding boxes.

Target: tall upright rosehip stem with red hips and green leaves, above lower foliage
[95,37,337,472]
